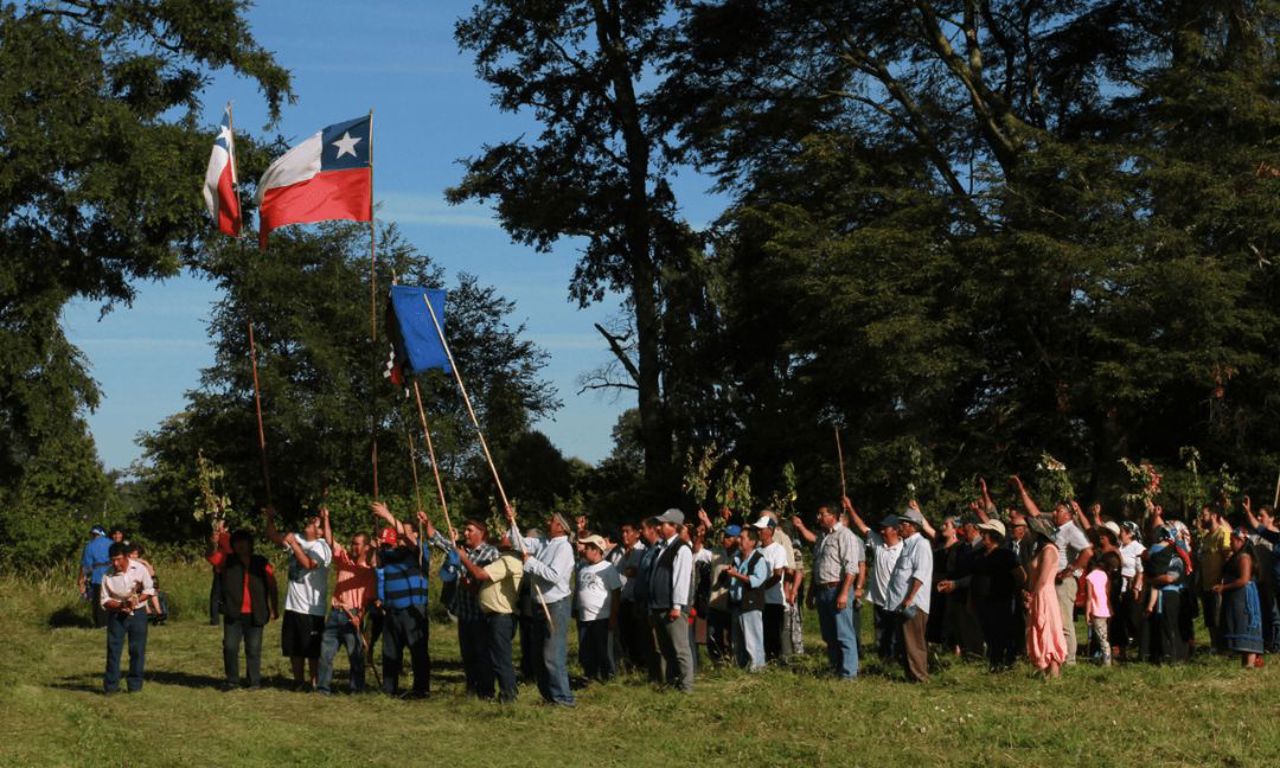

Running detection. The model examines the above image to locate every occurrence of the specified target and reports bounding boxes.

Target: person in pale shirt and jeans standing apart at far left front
[99,543,156,694]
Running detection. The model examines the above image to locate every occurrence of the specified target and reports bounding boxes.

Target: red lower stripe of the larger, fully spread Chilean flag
[259,168,374,247]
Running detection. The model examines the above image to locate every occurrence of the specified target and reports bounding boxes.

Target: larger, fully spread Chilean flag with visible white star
[257,115,374,248]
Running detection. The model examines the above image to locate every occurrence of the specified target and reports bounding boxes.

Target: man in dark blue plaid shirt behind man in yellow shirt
[419,512,498,699]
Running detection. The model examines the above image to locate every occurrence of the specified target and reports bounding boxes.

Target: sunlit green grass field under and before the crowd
[0,563,1280,768]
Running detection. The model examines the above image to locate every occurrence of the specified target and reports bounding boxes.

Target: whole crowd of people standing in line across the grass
[79,476,1280,707]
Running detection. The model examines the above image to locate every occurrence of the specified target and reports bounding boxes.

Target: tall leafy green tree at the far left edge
[0,0,291,563]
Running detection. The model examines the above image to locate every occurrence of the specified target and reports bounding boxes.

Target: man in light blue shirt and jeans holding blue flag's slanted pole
[507,507,575,707]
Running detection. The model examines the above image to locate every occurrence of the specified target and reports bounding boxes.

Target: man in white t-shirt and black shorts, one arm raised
[266,507,333,689]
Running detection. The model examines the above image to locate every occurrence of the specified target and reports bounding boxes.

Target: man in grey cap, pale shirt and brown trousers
[886,500,933,682]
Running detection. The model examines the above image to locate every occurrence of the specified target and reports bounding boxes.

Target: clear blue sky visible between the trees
[64,0,718,468]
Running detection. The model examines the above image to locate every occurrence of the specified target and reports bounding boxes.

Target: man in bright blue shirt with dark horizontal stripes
[371,502,431,698]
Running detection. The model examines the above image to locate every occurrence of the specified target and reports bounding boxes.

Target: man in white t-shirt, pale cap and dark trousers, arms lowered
[577,536,622,682]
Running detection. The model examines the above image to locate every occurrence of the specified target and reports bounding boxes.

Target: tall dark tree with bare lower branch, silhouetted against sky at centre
[449,0,707,499]
